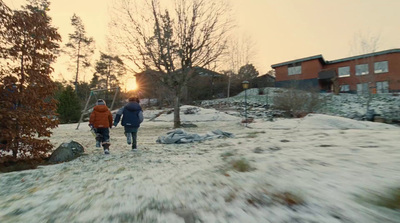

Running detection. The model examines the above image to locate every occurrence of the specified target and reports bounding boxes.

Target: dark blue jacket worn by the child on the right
[114,102,143,128]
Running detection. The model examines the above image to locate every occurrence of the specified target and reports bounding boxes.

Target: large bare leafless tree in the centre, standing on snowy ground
[112,0,231,128]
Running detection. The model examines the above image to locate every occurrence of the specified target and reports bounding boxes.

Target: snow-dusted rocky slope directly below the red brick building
[201,87,400,123]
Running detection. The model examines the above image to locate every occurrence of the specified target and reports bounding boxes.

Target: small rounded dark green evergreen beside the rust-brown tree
[57,86,81,123]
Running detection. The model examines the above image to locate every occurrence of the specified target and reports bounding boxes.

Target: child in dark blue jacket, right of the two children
[114,97,143,151]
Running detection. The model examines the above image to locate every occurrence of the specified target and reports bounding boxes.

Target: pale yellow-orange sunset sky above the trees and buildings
[3,0,400,89]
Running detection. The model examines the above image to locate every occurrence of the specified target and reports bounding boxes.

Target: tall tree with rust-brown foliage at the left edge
[0,0,61,159]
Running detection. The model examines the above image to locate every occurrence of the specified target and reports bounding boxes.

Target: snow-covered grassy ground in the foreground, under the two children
[0,106,400,223]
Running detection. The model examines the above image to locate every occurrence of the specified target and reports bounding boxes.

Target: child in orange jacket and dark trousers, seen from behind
[89,99,113,154]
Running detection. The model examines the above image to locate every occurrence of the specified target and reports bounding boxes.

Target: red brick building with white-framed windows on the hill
[271,49,400,93]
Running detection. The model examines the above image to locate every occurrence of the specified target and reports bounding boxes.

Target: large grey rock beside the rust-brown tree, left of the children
[49,140,85,163]
